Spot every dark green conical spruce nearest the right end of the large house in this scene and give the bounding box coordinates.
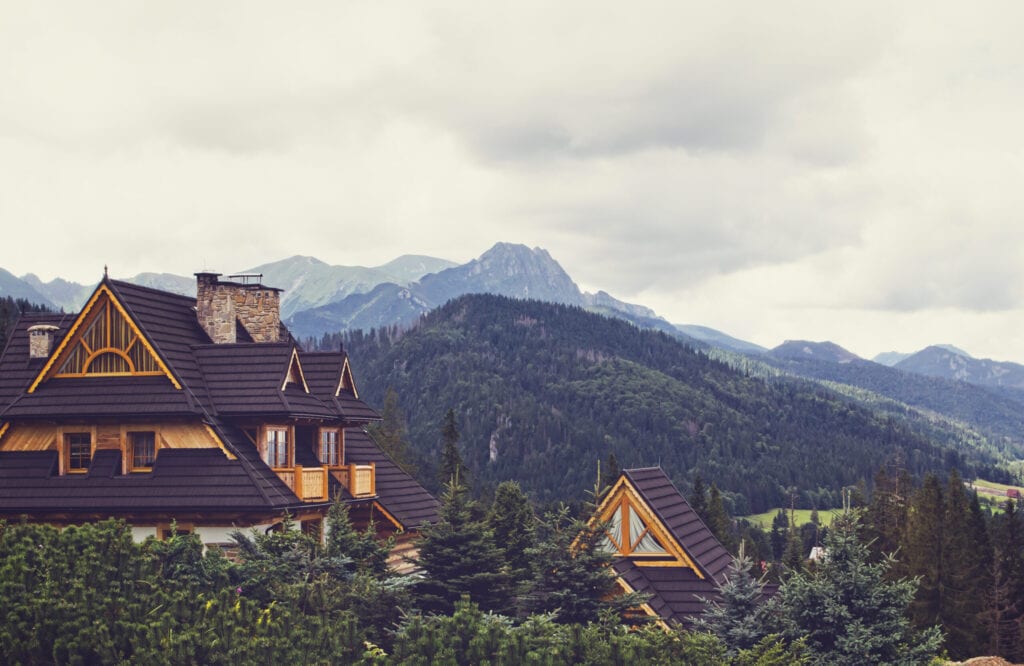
[413,477,512,613]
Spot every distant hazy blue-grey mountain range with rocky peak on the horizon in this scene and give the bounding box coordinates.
[6,243,1024,409]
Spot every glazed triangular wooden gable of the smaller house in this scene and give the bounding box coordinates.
[597,474,705,578]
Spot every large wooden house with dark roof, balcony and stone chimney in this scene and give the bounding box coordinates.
[0,273,438,545]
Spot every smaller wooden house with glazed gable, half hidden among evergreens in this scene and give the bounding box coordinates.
[597,467,732,625]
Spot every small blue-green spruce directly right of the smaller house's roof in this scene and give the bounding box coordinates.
[696,544,768,657]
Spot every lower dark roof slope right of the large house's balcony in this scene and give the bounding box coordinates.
[345,428,440,530]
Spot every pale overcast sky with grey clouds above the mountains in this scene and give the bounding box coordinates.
[0,0,1024,362]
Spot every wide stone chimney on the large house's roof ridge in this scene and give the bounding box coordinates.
[196,273,281,344]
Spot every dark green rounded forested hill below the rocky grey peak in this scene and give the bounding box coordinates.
[319,295,1000,512]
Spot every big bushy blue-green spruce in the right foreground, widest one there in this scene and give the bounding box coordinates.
[776,512,942,665]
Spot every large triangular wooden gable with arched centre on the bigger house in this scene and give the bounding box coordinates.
[28,282,181,393]
